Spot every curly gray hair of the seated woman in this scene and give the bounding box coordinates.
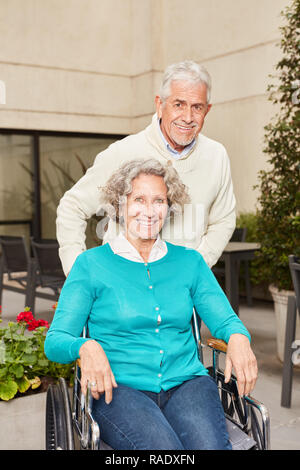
[100,158,190,221]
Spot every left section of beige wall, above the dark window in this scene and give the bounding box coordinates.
[0,0,133,133]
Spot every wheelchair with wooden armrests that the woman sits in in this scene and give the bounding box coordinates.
[46,311,270,450]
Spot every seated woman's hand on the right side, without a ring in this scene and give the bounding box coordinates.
[225,333,257,396]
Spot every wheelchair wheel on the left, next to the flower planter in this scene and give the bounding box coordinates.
[46,378,74,450]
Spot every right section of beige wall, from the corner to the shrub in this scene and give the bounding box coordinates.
[144,0,290,212]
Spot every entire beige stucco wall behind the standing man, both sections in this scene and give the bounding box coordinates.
[0,0,289,211]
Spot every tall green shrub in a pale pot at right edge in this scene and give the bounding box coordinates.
[257,0,300,360]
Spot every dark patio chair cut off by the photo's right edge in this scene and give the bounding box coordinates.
[281,255,300,408]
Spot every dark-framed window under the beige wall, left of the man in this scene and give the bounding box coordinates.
[0,126,123,248]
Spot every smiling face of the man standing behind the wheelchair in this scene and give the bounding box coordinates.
[155,80,211,152]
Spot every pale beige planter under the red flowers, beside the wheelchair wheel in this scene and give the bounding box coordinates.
[0,392,46,450]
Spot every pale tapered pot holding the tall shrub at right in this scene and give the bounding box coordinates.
[269,286,300,362]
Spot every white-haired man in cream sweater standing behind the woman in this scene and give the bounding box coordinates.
[57,61,235,274]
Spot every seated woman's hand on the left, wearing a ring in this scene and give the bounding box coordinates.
[79,340,118,404]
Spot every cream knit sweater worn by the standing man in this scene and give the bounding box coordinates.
[56,114,235,274]
